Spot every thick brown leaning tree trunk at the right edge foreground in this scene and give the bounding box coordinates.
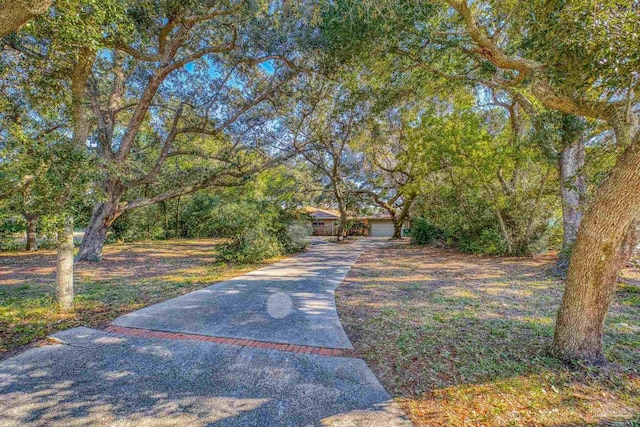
[554,132,640,363]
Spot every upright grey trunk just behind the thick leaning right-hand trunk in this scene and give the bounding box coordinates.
[556,137,587,271]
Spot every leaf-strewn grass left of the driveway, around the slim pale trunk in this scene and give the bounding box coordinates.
[0,240,280,358]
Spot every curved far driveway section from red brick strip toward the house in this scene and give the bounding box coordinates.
[113,239,370,349]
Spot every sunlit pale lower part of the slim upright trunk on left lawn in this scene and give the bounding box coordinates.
[56,215,73,310]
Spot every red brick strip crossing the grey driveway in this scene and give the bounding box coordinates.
[104,325,344,356]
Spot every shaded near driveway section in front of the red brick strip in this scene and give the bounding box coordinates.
[0,329,408,426]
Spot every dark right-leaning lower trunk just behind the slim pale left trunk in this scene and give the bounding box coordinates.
[77,201,122,262]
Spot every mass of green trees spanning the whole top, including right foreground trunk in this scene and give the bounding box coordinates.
[0,0,640,362]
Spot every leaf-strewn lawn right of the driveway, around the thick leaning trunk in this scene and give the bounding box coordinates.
[337,245,640,426]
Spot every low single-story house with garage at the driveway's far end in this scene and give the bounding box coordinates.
[304,207,410,237]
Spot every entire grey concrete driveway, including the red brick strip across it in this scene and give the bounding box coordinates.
[0,239,410,427]
